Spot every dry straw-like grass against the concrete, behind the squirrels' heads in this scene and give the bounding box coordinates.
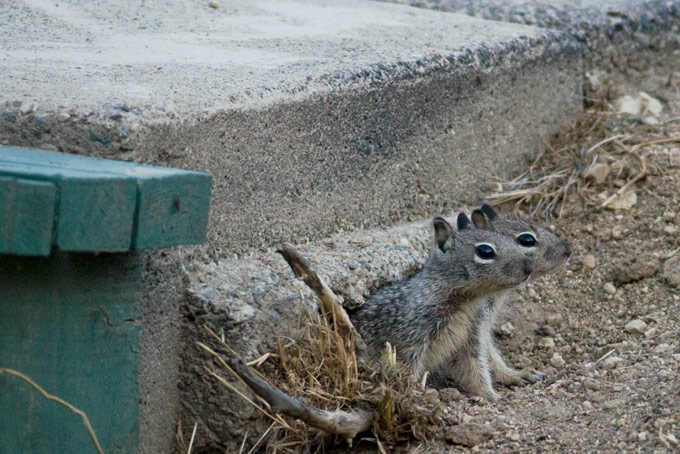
[488,101,680,219]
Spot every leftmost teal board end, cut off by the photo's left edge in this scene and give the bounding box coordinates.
[0,177,57,256]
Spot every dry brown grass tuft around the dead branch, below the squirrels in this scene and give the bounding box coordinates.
[201,296,442,453]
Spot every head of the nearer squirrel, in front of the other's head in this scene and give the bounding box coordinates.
[424,213,534,296]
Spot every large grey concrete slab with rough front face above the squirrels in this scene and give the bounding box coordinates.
[0,0,581,256]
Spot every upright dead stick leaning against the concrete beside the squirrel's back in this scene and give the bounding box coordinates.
[276,243,366,352]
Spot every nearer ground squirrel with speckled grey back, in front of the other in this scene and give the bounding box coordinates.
[350,213,534,395]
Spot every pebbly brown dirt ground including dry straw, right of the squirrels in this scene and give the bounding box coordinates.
[202,55,680,454]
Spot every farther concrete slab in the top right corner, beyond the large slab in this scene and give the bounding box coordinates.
[388,0,680,71]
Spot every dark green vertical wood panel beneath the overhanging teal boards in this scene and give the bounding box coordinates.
[0,252,143,454]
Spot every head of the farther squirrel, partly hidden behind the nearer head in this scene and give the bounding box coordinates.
[472,204,572,277]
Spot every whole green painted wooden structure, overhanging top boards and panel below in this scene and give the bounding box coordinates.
[0,146,211,454]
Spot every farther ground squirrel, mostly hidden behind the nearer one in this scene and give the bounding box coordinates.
[468,204,572,386]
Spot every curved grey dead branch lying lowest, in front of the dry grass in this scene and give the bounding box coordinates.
[224,353,373,439]
